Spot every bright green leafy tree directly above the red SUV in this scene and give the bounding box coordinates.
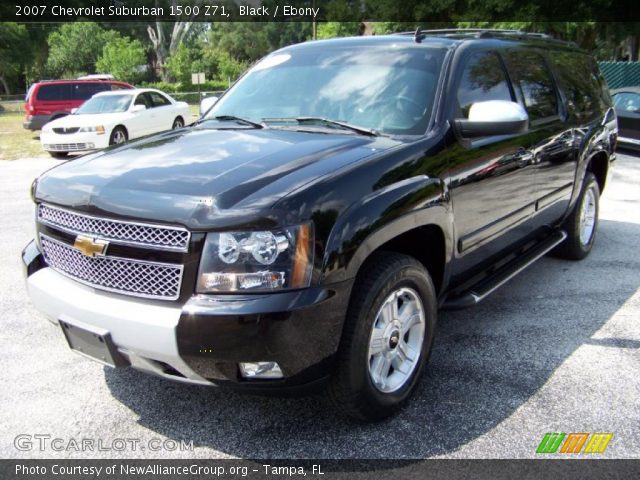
[47,22,120,76]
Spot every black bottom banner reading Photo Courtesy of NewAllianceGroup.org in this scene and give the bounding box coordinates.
[0,460,640,480]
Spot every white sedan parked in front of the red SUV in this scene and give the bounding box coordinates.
[40,88,191,157]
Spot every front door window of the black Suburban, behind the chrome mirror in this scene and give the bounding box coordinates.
[458,52,512,118]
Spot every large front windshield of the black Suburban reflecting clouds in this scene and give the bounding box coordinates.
[204,42,445,135]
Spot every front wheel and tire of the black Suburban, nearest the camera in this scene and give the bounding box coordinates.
[327,252,437,422]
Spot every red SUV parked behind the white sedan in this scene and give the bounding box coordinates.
[22,80,134,130]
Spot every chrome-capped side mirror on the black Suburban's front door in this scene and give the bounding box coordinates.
[455,100,529,137]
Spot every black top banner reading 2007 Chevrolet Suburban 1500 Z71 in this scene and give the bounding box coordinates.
[0,0,640,22]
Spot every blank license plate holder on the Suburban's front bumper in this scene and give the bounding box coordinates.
[59,319,129,367]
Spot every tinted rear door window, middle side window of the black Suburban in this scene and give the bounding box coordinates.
[507,50,558,120]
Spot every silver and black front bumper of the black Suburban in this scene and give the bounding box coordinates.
[22,242,352,391]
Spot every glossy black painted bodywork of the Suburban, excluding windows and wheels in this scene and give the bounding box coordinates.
[24,33,614,386]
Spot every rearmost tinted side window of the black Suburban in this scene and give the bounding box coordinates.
[551,52,601,114]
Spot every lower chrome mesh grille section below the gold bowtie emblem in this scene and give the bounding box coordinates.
[40,234,183,300]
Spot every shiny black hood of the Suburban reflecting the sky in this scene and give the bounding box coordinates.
[36,126,398,229]
